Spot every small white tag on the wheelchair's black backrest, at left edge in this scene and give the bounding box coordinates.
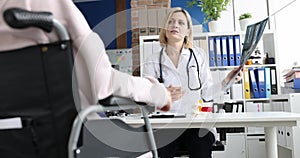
[0,117,22,130]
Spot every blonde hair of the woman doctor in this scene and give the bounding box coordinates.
[159,7,193,48]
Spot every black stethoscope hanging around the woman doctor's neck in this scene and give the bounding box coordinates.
[157,48,202,91]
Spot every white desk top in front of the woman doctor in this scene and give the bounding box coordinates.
[123,112,300,128]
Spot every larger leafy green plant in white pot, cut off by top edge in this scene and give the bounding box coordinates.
[187,0,230,32]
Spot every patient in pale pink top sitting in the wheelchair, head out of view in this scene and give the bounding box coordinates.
[0,0,171,111]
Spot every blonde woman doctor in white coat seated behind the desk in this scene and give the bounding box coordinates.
[143,8,241,158]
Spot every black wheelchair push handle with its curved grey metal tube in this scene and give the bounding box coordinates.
[3,8,70,41]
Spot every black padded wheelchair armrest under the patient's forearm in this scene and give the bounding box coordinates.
[98,95,146,107]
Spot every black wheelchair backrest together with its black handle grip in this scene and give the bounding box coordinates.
[0,8,77,158]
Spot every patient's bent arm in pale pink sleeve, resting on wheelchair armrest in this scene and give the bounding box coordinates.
[75,33,170,110]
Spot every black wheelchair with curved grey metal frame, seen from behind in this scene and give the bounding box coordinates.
[0,8,157,158]
